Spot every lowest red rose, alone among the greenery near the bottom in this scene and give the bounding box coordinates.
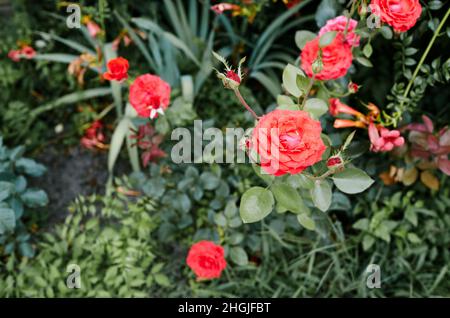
[186,241,227,279]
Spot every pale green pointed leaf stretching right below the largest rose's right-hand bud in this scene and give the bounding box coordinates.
[332,168,374,194]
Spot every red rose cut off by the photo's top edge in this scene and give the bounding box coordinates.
[370,0,422,32]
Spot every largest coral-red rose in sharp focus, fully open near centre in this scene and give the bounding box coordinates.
[252,110,326,176]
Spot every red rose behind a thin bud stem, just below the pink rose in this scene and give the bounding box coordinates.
[301,33,353,80]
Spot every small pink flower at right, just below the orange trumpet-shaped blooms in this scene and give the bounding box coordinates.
[369,123,405,152]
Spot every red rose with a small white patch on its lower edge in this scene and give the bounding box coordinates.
[130,74,171,119]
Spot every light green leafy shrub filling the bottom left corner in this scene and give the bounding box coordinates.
[0,194,172,297]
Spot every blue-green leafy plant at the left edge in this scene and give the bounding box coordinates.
[0,136,48,258]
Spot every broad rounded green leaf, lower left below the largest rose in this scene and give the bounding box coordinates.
[239,187,275,223]
